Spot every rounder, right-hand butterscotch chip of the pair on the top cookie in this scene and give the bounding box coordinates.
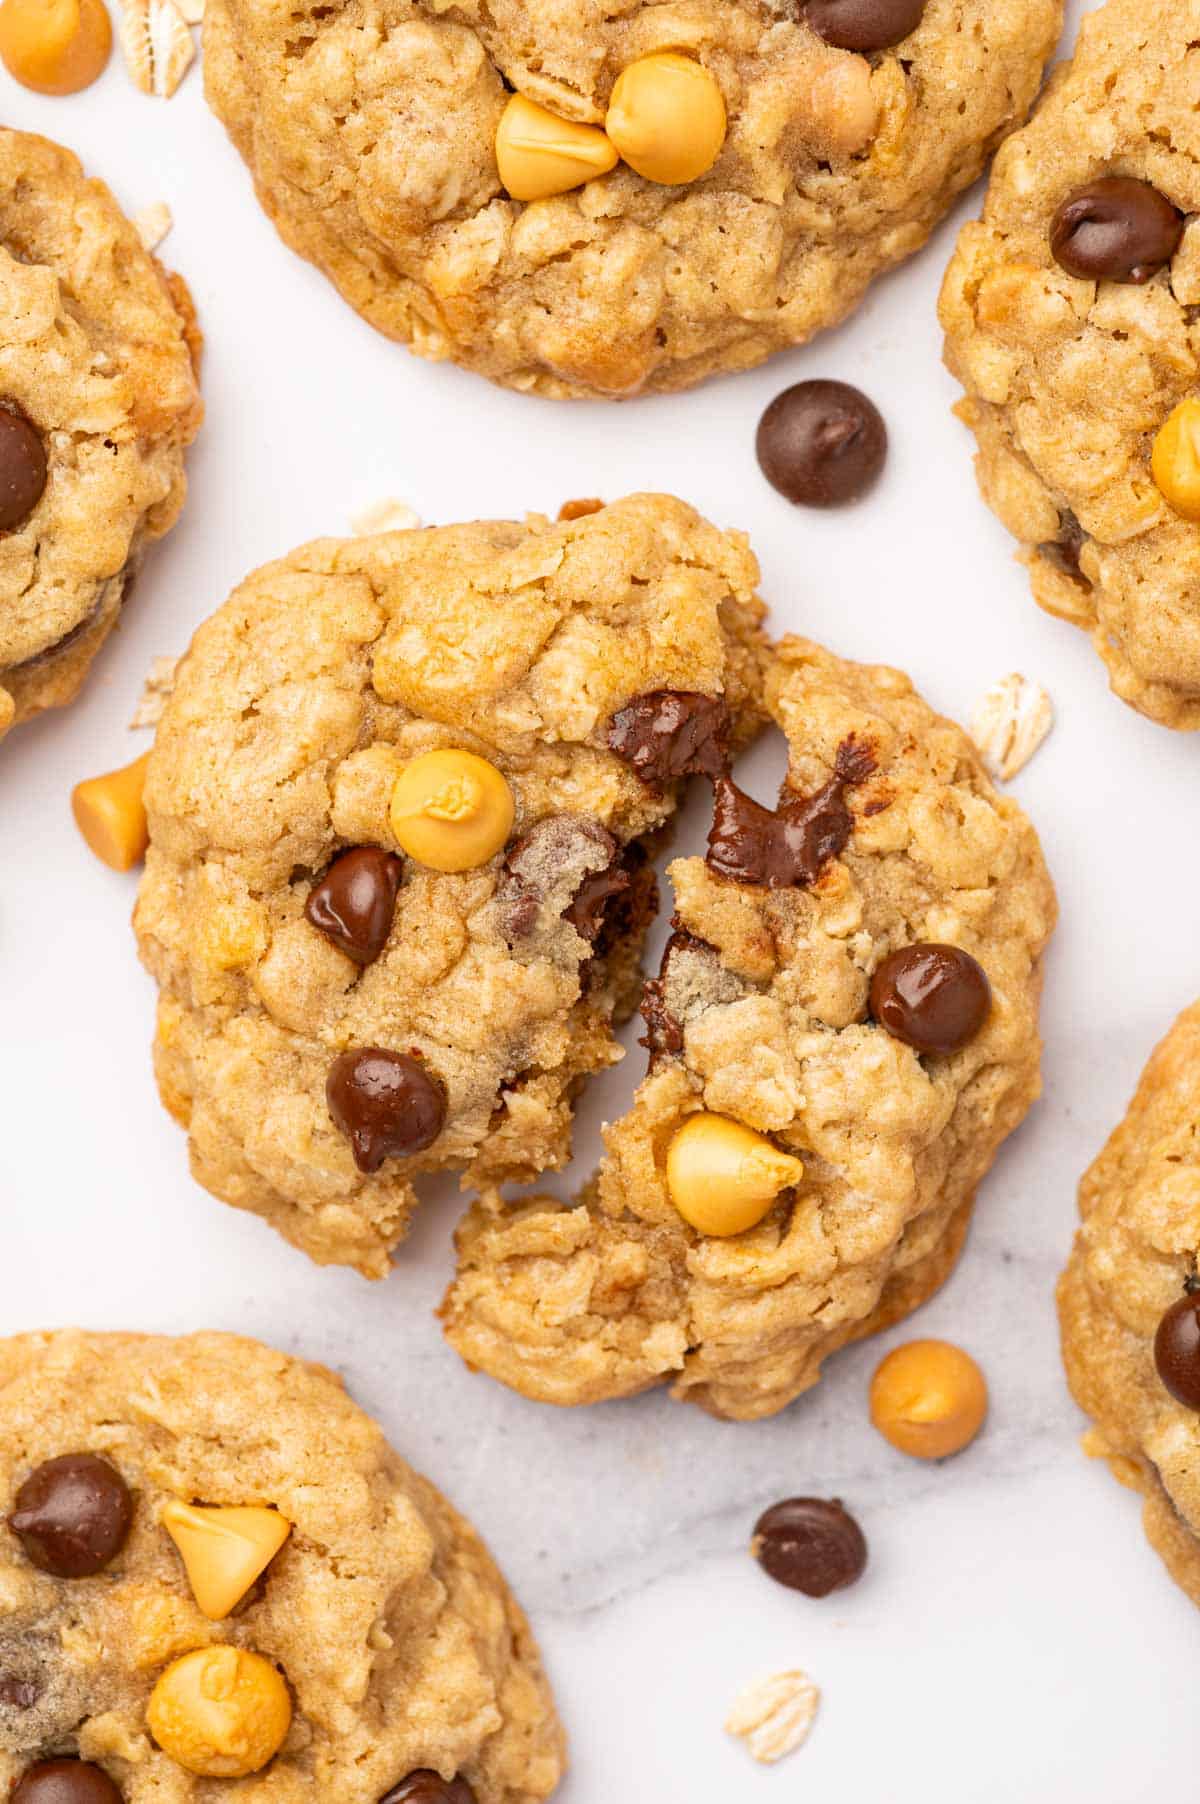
[605,51,727,186]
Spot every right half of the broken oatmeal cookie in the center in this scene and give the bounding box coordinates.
[442,639,1056,1418]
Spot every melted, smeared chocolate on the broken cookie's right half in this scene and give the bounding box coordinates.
[707,740,875,889]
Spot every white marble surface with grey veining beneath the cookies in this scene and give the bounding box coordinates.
[0,10,1200,1804]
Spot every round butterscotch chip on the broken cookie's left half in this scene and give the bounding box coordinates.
[388,749,516,871]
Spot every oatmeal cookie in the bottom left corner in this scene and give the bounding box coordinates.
[0,1331,563,1804]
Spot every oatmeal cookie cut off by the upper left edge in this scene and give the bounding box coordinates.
[0,128,200,738]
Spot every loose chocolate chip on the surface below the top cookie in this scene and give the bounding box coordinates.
[756,381,888,507]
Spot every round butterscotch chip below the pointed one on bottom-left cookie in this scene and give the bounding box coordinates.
[146,1645,292,1779]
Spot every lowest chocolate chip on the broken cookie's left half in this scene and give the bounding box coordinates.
[325,1046,446,1173]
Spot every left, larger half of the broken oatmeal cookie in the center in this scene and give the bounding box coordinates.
[135,496,762,1277]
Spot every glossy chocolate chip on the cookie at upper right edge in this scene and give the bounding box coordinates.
[1050,175,1184,283]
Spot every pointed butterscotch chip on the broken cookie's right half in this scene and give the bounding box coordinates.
[666,1111,805,1236]
